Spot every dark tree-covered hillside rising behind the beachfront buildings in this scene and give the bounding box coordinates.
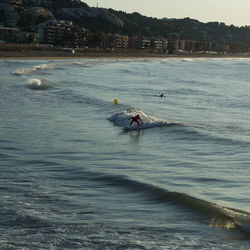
[0,0,250,48]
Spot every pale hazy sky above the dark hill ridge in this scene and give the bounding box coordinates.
[82,0,250,26]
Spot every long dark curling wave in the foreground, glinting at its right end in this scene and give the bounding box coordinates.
[95,174,250,233]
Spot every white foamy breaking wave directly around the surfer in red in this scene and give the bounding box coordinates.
[109,107,177,130]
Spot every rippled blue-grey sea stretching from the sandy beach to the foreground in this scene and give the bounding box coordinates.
[0,58,250,249]
